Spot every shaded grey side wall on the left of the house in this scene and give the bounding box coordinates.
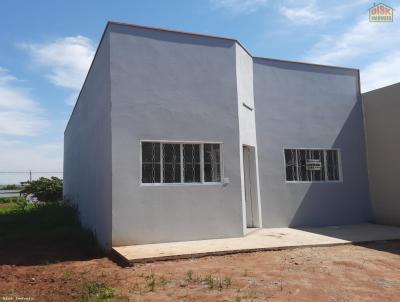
[64,33,112,248]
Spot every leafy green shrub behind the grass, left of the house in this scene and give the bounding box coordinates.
[21,176,63,202]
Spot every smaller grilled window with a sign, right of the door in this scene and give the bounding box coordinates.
[284,149,340,182]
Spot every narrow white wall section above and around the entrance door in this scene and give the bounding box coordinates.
[236,44,262,229]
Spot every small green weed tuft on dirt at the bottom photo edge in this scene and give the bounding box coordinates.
[76,281,116,302]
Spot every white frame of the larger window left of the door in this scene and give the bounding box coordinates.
[139,139,224,186]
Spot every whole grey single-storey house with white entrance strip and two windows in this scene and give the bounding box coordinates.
[64,22,371,248]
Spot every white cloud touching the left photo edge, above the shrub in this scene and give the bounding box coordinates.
[0,67,47,136]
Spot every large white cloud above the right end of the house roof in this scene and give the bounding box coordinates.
[303,6,400,92]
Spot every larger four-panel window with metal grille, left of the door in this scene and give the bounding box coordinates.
[142,142,222,184]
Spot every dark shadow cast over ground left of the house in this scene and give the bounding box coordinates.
[0,204,104,265]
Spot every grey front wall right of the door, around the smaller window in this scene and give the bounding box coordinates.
[254,58,371,227]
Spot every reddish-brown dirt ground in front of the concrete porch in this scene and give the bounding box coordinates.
[0,241,400,301]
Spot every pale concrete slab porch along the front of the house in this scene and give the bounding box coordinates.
[112,224,400,264]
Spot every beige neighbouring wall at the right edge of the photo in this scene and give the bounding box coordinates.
[363,84,400,225]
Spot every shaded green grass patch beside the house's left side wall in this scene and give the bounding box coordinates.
[0,203,101,254]
